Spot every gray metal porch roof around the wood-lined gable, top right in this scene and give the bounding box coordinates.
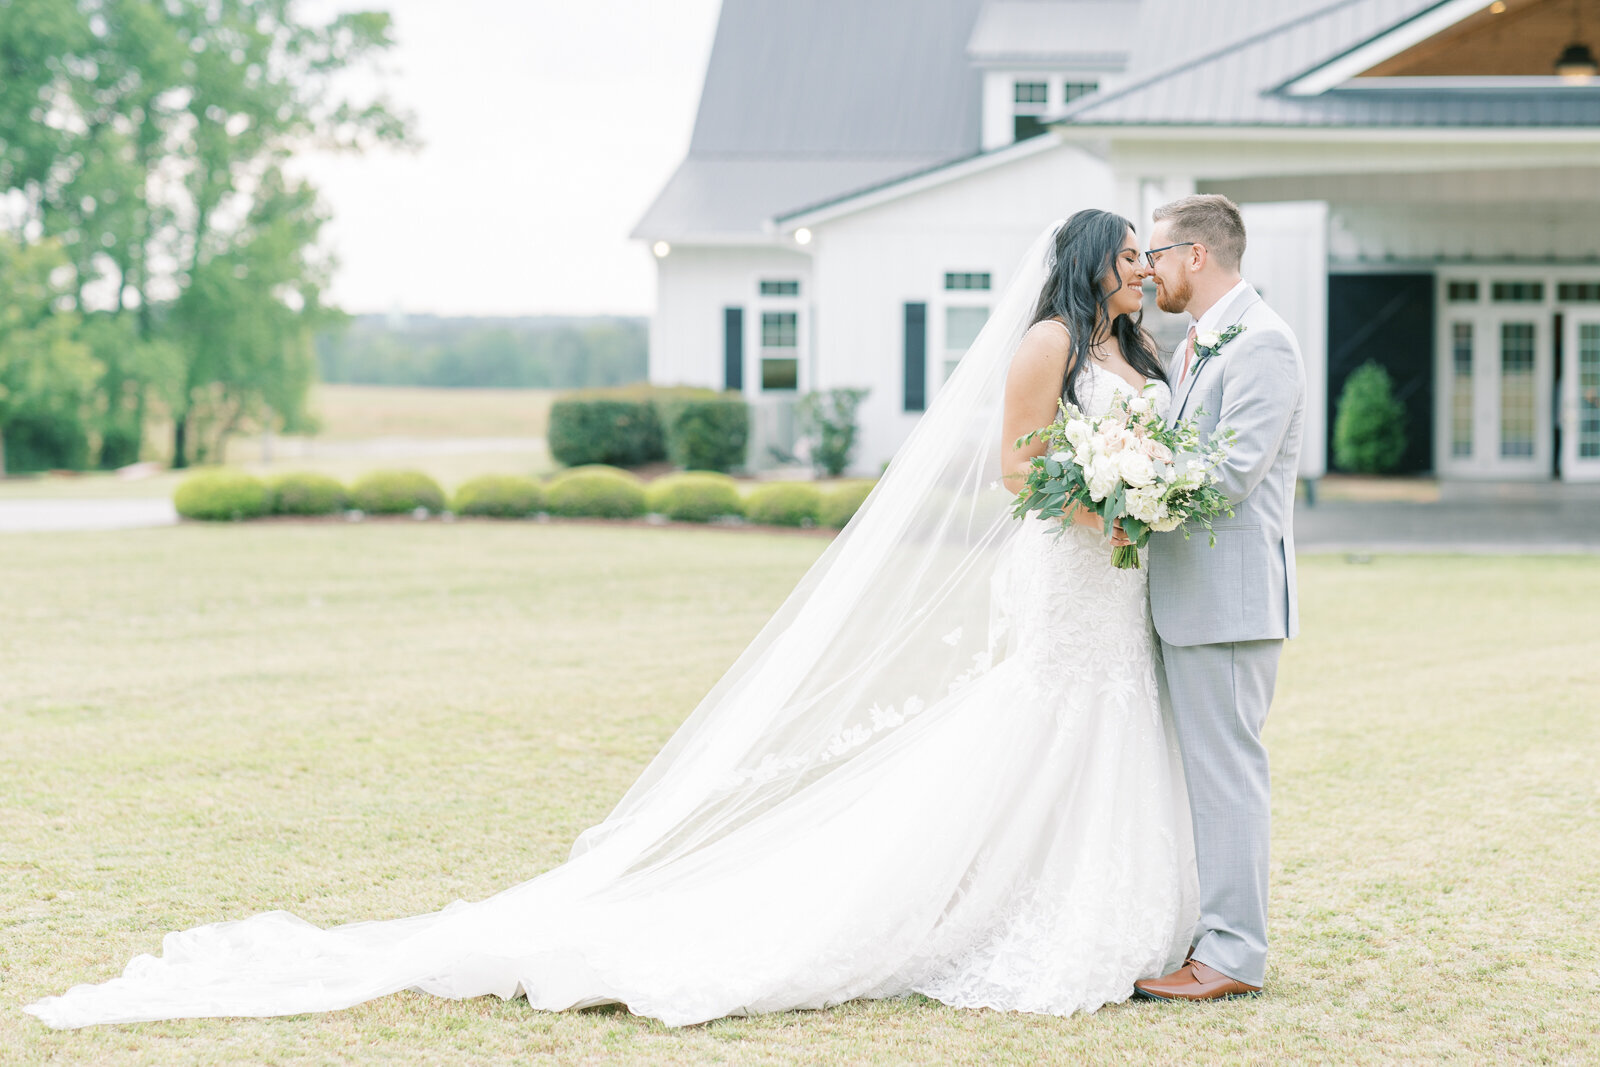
[1064,0,1600,126]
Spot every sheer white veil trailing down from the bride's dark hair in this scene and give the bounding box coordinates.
[573,221,1061,872]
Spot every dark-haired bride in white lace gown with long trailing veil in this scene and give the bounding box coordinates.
[27,211,1197,1027]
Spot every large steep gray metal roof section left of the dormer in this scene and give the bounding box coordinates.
[634,0,982,240]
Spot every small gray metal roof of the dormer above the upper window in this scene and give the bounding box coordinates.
[966,0,1142,70]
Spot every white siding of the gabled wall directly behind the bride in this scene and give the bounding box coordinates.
[813,140,1112,474]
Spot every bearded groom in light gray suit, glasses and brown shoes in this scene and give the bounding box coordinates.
[1134,195,1306,1000]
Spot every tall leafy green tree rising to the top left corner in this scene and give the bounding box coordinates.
[0,0,406,466]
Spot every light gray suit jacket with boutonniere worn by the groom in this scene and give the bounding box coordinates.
[1149,286,1306,645]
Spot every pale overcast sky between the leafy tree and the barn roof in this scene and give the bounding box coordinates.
[299,0,720,315]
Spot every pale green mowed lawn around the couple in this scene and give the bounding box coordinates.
[0,523,1600,1064]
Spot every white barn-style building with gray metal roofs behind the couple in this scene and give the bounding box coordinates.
[635,0,1600,482]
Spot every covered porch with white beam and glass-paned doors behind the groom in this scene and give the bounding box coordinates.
[1112,130,1600,483]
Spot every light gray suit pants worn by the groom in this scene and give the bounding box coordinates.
[1162,640,1283,985]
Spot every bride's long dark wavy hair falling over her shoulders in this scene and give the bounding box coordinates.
[1029,208,1166,408]
